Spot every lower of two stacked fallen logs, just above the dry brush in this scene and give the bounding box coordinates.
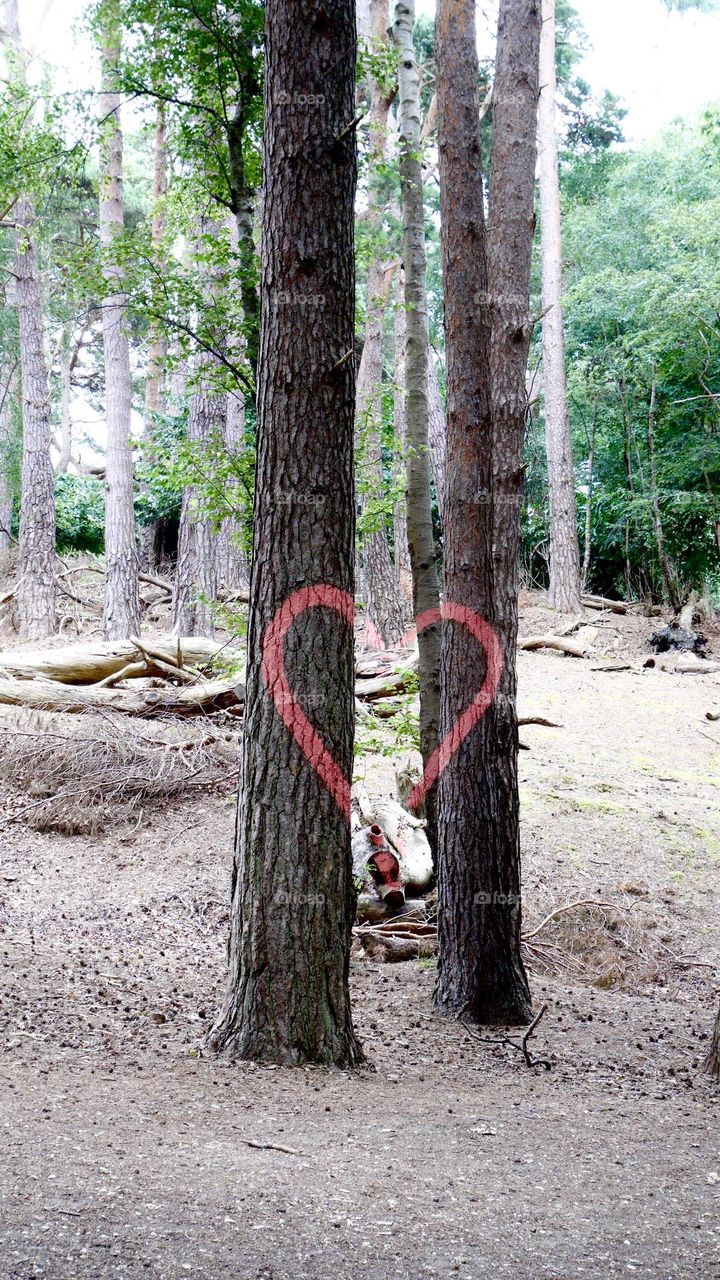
[0,673,245,717]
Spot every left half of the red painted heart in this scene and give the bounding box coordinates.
[263,584,355,822]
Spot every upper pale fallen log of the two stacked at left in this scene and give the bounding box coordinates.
[0,636,220,685]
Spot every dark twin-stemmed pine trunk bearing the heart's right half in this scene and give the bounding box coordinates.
[427,0,541,1024]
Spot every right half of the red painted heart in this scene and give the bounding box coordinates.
[407,602,502,809]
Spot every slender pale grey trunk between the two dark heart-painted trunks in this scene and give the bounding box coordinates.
[392,0,441,854]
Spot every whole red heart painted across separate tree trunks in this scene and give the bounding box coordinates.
[263,584,502,818]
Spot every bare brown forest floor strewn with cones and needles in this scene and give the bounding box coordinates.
[0,586,720,1280]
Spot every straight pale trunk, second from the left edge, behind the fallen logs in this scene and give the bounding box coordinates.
[100,0,140,640]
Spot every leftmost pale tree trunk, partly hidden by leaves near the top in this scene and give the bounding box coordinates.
[4,0,56,640]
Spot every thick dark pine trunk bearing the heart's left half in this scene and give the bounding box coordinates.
[210,0,363,1066]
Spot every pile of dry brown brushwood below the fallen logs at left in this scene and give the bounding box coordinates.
[0,710,240,836]
